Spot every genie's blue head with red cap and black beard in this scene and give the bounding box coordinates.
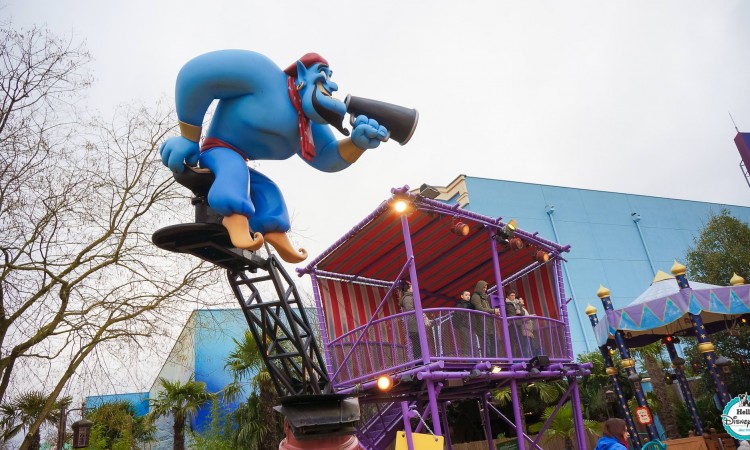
[284,53,349,136]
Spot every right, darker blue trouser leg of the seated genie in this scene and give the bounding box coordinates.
[250,169,290,234]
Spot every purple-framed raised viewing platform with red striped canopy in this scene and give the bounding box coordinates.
[297,186,591,450]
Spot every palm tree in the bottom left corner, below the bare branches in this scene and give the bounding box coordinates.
[0,391,72,450]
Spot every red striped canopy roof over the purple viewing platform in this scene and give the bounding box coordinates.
[301,189,568,299]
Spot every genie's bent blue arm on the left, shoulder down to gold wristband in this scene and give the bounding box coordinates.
[175,50,284,127]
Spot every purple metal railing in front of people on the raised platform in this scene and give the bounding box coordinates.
[328,308,569,388]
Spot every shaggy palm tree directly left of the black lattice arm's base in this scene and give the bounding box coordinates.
[224,331,280,450]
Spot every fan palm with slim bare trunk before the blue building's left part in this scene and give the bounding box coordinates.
[151,376,214,450]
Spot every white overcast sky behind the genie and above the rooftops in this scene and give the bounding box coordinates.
[5,0,750,392]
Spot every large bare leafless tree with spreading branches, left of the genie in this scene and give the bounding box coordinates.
[0,26,219,448]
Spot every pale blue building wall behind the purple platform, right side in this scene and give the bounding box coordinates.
[465,176,750,353]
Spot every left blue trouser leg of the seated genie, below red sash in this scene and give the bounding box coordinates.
[199,147,257,217]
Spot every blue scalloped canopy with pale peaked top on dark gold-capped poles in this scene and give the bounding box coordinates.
[599,271,750,347]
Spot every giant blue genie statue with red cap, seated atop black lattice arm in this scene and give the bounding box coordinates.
[161,50,394,263]
